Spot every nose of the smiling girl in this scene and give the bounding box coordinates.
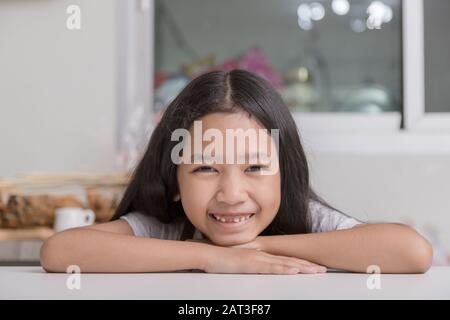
[216,172,248,205]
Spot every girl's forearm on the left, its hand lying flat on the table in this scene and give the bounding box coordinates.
[41,229,209,273]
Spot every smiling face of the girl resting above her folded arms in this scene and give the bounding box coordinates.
[177,112,281,246]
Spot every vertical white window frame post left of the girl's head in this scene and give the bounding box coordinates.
[116,0,154,171]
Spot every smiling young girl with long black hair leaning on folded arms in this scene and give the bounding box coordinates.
[41,70,433,274]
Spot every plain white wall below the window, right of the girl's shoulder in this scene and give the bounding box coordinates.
[308,152,450,252]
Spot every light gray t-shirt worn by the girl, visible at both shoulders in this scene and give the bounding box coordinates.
[120,201,362,240]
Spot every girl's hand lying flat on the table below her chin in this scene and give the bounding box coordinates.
[203,246,327,274]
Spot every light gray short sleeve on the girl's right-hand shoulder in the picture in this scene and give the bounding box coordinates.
[309,201,363,232]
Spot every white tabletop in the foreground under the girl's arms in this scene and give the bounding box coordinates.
[0,267,450,300]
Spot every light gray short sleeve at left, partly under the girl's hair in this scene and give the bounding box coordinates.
[120,212,183,240]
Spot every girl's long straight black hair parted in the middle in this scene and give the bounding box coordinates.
[112,70,338,235]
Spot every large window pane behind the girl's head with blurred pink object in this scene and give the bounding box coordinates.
[154,0,403,114]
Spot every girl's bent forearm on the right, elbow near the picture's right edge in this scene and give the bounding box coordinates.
[260,224,433,273]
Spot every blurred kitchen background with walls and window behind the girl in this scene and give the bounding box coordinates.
[0,0,450,265]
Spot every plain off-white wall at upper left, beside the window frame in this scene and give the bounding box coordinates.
[0,0,117,177]
